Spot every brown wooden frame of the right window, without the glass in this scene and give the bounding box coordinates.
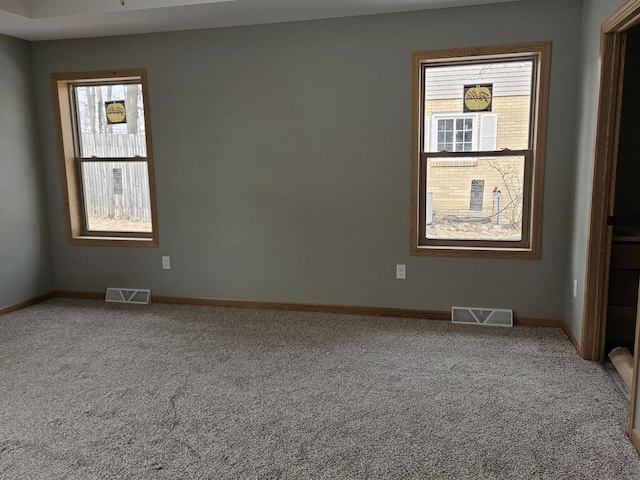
[410,42,551,259]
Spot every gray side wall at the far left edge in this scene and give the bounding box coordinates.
[0,35,53,308]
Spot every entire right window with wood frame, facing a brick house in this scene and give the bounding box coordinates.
[411,43,551,258]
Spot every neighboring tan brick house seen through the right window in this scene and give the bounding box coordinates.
[424,62,533,231]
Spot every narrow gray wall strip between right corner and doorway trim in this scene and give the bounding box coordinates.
[564,0,626,340]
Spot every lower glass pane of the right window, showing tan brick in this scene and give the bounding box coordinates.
[425,156,524,241]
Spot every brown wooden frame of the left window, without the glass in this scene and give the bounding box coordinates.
[51,68,159,247]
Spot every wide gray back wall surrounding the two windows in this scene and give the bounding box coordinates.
[33,0,581,318]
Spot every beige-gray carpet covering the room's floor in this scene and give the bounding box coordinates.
[0,299,640,480]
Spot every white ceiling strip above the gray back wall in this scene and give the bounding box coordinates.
[0,0,518,40]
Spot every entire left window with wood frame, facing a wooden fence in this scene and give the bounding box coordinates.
[52,69,158,246]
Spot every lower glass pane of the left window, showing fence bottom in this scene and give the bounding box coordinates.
[82,162,151,232]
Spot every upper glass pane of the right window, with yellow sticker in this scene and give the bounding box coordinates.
[424,60,533,152]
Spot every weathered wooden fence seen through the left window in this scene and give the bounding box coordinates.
[81,133,151,222]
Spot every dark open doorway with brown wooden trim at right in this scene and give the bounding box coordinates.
[581,0,640,451]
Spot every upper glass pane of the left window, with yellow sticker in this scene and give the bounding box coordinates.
[73,83,147,158]
